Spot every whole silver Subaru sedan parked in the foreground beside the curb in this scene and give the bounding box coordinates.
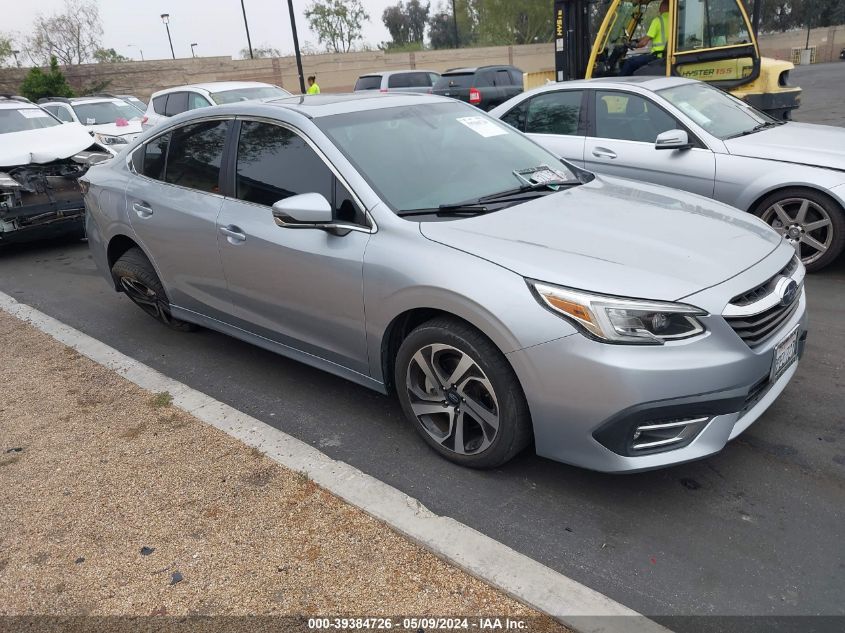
[83,94,807,472]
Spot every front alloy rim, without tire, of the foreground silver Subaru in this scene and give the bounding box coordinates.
[405,344,499,455]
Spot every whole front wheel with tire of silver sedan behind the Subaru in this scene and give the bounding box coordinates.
[751,187,845,272]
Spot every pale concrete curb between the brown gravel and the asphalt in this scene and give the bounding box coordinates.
[0,292,668,633]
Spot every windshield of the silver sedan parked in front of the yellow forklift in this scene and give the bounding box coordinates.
[657,83,777,139]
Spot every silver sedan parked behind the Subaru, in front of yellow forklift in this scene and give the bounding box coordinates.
[490,77,845,271]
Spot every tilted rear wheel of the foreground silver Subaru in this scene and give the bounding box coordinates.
[111,247,197,332]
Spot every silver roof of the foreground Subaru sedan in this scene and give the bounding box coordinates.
[258,91,460,119]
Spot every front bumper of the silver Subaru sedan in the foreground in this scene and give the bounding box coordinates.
[508,289,807,472]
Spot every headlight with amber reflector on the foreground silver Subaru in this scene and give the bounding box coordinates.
[529,281,707,345]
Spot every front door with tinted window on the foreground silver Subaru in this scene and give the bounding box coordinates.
[218,121,370,374]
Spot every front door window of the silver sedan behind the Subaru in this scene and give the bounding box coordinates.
[595,90,681,143]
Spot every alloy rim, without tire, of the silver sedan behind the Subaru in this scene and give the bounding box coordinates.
[760,198,833,265]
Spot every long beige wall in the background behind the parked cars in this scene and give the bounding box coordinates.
[0,26,845,98]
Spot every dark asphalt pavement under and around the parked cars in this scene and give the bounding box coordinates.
[0,63,845,631]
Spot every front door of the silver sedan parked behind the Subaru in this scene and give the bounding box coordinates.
[584,90,716,197]
